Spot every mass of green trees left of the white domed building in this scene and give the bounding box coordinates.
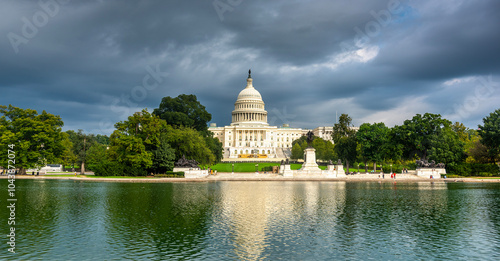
[0,94,222,176]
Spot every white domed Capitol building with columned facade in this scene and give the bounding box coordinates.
[208,71,358,161]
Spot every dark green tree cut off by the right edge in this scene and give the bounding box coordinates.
[479,109,500,163]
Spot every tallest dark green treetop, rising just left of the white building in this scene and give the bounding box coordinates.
[153,94,212,132]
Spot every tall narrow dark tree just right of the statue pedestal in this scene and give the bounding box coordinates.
[332,114,357,171]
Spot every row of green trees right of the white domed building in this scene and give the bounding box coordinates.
[292,109,500,174]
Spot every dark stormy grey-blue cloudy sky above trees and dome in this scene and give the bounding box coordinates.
[0,0,500,134]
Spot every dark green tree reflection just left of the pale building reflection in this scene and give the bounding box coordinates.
[106,183,213,259]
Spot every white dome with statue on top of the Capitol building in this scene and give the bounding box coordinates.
[231,70,269,126]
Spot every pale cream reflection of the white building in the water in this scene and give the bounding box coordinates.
[209,182,345,260]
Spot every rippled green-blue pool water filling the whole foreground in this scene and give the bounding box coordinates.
[0,180,500,260]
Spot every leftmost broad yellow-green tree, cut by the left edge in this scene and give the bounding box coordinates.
[0,105,64,174]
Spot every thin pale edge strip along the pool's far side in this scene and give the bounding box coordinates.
[0,173,500,183]
